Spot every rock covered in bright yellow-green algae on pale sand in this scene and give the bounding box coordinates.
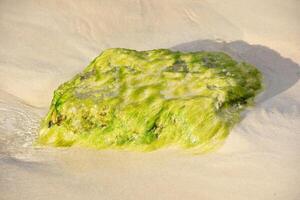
[38,48,262,152]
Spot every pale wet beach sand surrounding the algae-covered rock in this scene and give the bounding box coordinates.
[0,0,300,200]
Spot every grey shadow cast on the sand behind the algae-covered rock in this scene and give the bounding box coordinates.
[170,40,300,103]
